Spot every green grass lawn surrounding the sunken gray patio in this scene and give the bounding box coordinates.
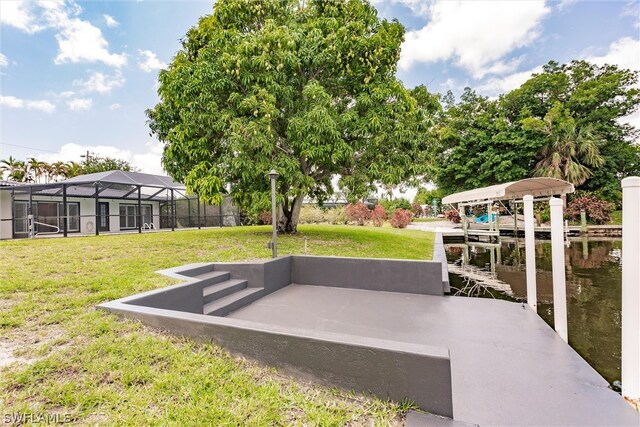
[0,225,433,426]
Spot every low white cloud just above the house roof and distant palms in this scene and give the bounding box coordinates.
[38,141,165,175]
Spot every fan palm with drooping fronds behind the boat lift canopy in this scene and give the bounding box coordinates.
[523,102,605,186]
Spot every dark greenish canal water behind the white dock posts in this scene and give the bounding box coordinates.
[445,238,622,383]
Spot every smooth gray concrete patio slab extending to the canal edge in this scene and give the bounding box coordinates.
[228,284,640,426]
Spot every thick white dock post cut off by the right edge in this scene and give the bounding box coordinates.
[622,176,640,399]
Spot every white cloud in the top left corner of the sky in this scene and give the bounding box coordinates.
[0,0,127,68]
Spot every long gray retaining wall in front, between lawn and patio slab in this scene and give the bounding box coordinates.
[99,301,453,417]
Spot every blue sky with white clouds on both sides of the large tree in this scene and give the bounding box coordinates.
[0,0,640,173]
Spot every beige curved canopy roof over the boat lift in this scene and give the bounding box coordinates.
[442,178,575,204]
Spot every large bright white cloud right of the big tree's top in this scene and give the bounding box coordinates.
[399,0,550,79]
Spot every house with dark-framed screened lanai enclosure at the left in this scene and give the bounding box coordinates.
[0,171,240,239]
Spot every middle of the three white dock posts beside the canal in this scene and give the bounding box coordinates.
[549,197,569,342]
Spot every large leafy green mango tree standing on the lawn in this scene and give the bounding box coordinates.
[147,0,439,232]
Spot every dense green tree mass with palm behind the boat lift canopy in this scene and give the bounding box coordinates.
[435,61,640,201]
